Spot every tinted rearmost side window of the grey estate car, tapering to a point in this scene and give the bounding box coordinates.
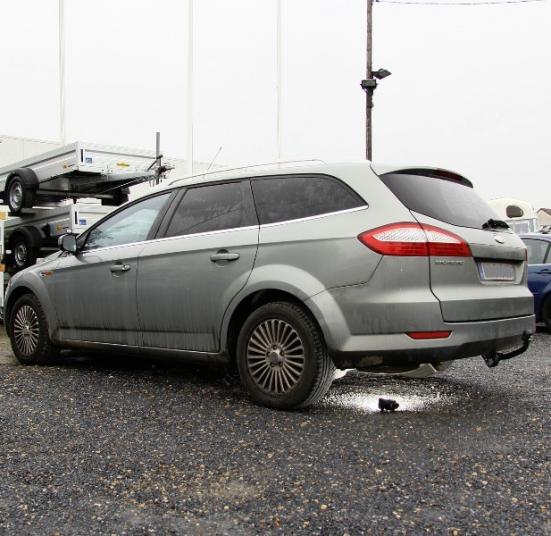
[252,175,366,224]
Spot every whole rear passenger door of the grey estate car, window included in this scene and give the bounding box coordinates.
[137,180,258,352]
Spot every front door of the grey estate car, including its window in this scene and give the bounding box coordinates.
[54,192,170,346]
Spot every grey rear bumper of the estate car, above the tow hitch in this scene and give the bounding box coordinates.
[308,292,535,368]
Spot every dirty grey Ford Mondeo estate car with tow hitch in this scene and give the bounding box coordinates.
[5,162,535,408]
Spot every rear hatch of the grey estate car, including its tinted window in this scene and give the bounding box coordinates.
[379,165,533,322]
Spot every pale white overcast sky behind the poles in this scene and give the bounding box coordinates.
[0,0,551,208]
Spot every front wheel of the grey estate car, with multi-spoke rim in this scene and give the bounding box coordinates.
[6,294,59,365]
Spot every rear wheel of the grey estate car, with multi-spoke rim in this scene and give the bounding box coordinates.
[236,302,335,409]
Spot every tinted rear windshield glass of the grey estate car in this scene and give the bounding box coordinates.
[380,172,498,229]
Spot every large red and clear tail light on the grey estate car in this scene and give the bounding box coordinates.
[358,222,471,257]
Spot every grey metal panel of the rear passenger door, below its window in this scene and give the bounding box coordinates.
[137,226,258,352]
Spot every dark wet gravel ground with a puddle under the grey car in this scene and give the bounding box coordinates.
[0,326,551,535]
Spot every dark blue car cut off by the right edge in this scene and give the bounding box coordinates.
[521,233,551,331]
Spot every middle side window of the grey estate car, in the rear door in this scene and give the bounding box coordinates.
[165,181,258,236]
